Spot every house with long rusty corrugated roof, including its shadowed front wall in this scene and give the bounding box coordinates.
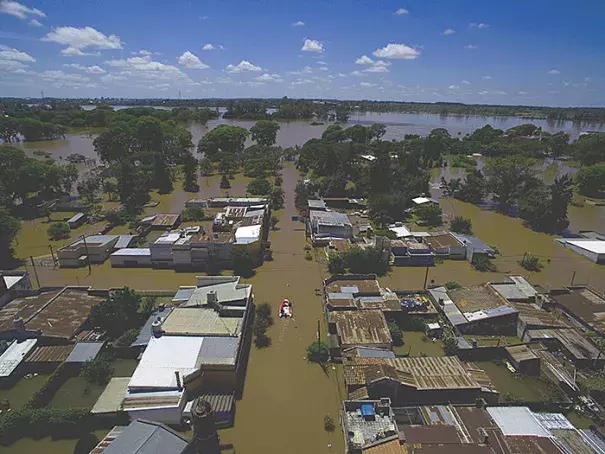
[343,356,499,406]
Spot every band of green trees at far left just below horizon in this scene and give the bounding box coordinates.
[0,100,218,142]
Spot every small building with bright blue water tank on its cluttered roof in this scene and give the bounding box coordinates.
[342,398,407,454]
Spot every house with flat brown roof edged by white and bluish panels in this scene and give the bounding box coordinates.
[429,284,519,335]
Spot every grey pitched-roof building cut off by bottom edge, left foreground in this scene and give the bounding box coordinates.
[90,419,189,454]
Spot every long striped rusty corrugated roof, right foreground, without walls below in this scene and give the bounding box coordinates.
[344,356,481,390]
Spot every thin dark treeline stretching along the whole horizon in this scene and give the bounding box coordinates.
[0,97,605,124]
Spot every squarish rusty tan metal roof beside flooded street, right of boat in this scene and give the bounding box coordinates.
[330,310,393,345]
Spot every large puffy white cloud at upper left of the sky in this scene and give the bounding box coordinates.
[42,27,122,56]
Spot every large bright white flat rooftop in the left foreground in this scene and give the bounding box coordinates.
[128,336,204,391]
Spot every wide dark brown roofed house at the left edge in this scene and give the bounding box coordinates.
[0,287,104,344]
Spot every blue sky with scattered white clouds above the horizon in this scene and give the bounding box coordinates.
[0,0,605,106]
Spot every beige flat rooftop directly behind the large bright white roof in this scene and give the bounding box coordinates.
[162,307,243,340]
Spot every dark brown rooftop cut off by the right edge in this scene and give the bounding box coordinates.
[550,287,605,331]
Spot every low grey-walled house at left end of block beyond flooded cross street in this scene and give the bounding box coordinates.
[57,235,135,268]
